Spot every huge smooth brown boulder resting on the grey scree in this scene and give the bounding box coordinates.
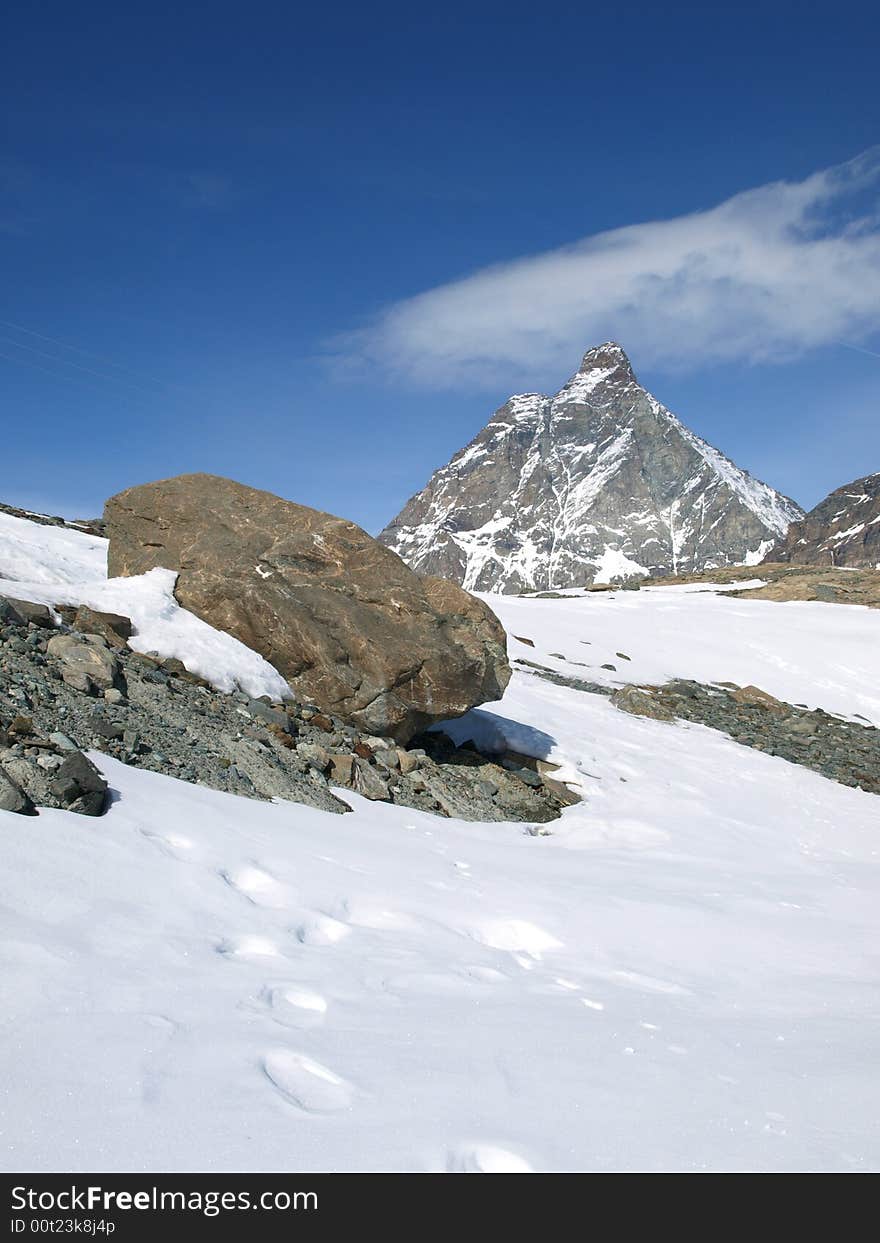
[104,475,510,741]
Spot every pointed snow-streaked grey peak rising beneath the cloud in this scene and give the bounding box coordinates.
[379,342,803,593]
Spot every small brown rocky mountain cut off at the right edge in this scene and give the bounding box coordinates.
[767,471,880,569]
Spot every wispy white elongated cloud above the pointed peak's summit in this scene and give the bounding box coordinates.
[341,148,880,385]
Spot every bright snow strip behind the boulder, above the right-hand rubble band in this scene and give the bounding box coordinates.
[481,573,880,726]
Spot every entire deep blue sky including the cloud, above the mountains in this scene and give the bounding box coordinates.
[0,0,880,531]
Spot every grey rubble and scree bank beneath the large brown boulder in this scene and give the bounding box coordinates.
[0,597,577,824]
